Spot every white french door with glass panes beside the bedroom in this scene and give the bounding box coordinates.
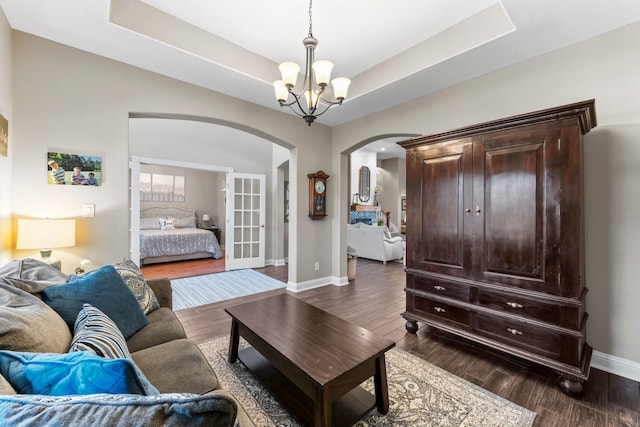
[225,172,266,270]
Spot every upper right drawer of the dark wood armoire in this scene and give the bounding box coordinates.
[478,289,561,325]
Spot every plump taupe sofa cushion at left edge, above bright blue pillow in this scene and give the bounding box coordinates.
[0,284,71,353]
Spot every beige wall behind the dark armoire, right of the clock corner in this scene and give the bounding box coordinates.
[332,24,640,363]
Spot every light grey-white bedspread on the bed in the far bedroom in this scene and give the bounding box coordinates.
[140,228,222,259]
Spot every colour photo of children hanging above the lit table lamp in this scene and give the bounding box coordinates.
[47,151,102,186]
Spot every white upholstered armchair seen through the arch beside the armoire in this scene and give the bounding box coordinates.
[347,223,403,264]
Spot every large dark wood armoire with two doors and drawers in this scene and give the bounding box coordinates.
[400,100,596,394]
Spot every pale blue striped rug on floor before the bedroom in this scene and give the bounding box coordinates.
[171,269,287,311]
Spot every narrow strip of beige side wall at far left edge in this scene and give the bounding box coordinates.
[0,9,13,265]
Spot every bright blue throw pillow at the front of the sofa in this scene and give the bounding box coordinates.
[0,351,158,396]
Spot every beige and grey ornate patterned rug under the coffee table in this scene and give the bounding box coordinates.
[199,337,536,427]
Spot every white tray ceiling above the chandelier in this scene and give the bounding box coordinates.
[0,0,640,157]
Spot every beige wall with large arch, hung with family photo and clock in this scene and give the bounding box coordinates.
[12,32,331,283]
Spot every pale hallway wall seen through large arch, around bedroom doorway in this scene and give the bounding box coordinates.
[129,113,295,284]
